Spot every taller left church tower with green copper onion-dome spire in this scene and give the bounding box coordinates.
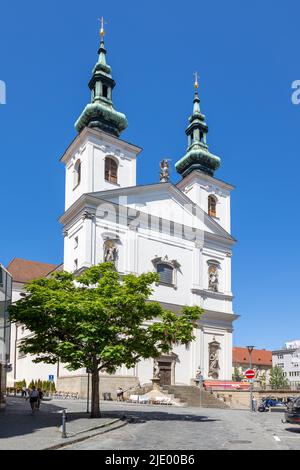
[61,18,141,210]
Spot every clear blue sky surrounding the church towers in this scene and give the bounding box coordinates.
[0,0,300,348]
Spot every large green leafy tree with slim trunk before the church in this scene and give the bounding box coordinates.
[9,263,203,417]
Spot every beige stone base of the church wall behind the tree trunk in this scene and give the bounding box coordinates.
[56,374,139,400]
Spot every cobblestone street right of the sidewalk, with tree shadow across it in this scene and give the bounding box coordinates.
[64,404,300,450]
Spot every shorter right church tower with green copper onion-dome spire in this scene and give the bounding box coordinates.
[175,73,234,233]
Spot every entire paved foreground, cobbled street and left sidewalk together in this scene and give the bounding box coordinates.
[0,398,300,450]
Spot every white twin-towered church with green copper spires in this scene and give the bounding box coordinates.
[7,25,237,396]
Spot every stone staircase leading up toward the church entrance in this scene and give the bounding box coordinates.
[161,385,228,409]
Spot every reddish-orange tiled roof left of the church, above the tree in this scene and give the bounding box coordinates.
[7,258,57,282]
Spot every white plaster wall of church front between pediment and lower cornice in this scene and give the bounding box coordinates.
[64,219,232,313]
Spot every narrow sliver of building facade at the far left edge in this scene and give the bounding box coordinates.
[0,264,12,409]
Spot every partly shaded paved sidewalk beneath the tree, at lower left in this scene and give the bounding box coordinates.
[0,397,126,450]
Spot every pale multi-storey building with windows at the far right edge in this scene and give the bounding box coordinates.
[272,339,300,389]
